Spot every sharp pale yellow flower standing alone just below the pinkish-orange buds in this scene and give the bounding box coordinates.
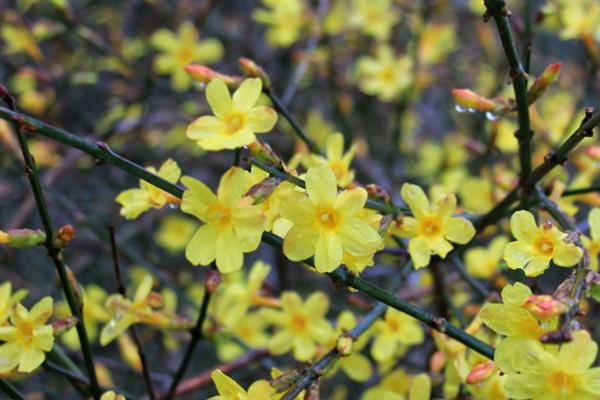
[187,78,277,150]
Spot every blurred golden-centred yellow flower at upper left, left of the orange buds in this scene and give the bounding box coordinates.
[150,21,224,92]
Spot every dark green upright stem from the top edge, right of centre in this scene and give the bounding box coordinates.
[484,0,533,181]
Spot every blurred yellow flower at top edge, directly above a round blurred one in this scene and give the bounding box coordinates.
[348,0,400,40]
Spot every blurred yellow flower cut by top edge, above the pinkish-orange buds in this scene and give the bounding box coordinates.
[252,0,306,47]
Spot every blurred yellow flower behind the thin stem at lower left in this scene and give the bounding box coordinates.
[55,283,110,350]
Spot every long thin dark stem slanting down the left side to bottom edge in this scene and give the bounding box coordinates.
[2,96,100,398]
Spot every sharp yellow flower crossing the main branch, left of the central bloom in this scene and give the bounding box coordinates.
[181,167,266,273]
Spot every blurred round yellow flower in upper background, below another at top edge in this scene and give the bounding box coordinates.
[356,45,413,102]
